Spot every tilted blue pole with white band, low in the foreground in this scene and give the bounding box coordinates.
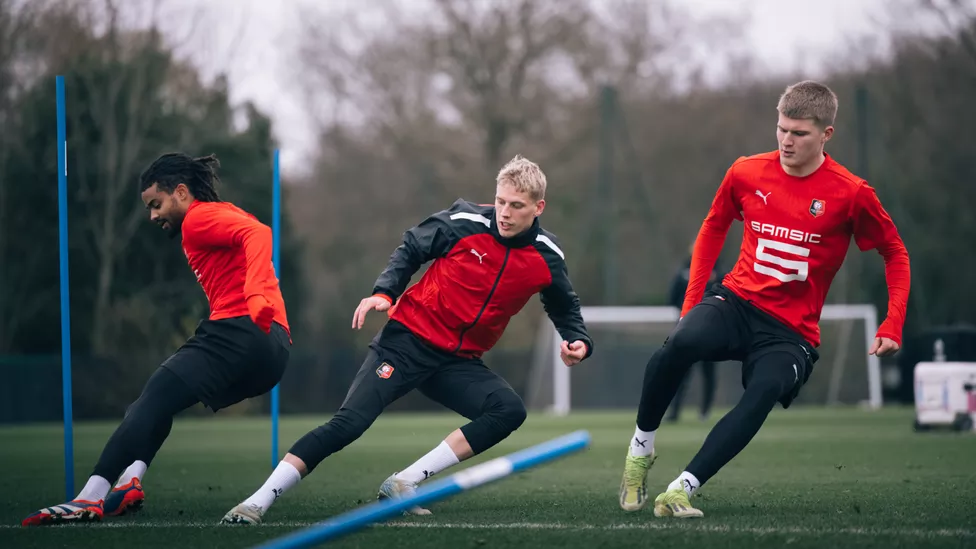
[248,431,590,549]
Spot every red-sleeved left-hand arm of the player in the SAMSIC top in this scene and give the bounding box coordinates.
[681,165,742,317]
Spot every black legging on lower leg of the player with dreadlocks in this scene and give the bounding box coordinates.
[92,367,200,483]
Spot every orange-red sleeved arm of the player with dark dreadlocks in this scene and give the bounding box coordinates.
[183,208,275,332]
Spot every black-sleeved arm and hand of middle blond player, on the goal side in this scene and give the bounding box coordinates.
[539,239,593,365]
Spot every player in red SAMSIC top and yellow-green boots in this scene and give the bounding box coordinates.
[620,81,911,518]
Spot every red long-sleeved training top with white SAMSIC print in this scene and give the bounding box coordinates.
[681,151,911,346]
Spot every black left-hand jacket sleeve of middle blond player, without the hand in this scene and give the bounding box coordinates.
[373,200,464,303]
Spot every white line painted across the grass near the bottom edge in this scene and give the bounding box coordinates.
[0,520,976,538]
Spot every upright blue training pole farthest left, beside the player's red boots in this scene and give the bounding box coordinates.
[55,76,75,501]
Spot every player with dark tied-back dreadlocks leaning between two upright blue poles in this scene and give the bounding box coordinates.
[23,153,291,526]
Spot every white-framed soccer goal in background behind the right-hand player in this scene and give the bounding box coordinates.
[527,305,882,415]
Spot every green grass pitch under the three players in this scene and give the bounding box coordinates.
[0,408,976,549]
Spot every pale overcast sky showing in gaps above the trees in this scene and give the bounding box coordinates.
[141,0,948,171]
